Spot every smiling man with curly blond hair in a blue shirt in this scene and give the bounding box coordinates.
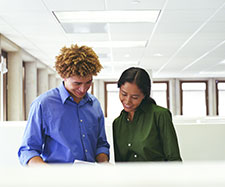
[18,45,109,165]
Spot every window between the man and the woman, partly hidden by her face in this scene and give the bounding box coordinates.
[104,82,123,119]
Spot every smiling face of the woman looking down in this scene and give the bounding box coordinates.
[119,82,145,113]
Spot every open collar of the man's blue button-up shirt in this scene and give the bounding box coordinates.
[58,81,93,104]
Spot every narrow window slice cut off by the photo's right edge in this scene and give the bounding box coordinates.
[216,80,225,116]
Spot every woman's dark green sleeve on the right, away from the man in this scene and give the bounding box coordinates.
[158,110,182,161]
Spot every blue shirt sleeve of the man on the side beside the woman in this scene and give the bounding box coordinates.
[96,110,110,157]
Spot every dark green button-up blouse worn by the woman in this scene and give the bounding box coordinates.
[113,98,181,162]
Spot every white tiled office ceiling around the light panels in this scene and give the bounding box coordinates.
[0,0,225,78]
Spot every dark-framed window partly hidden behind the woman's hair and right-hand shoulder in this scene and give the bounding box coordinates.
[151,81,169,109]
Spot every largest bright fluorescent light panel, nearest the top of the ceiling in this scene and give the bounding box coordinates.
[54,10,160,23]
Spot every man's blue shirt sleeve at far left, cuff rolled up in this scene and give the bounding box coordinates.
[18,102,43,165]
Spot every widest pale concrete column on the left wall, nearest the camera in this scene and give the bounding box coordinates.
[7,50,25,121]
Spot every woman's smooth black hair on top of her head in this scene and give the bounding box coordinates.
[117,67,151,98]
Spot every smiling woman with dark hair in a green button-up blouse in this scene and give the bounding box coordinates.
[113,67,182,162]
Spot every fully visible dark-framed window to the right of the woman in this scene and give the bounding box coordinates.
[180,81,208,116]
